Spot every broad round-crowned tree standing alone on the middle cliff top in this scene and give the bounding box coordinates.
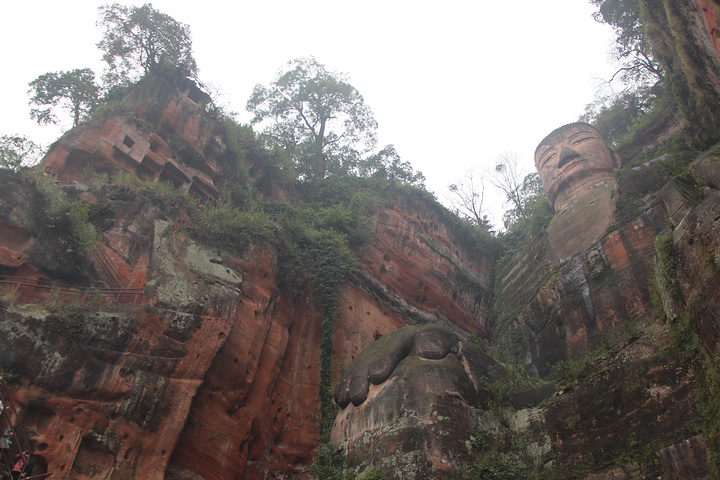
[247,57,377,180]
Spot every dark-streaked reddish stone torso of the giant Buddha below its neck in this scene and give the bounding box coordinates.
[495,158,668,376]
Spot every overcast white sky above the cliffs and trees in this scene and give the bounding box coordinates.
[0,0,612,228]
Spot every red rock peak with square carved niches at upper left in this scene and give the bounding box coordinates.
[43,77,225,202]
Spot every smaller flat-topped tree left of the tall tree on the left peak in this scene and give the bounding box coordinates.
[28,68,99,126]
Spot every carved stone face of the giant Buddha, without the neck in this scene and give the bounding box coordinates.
[535,123,620,211]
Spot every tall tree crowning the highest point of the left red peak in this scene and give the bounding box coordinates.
[97,3,197,85]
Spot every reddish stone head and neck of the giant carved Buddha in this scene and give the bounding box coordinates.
[535,123,620,260]
